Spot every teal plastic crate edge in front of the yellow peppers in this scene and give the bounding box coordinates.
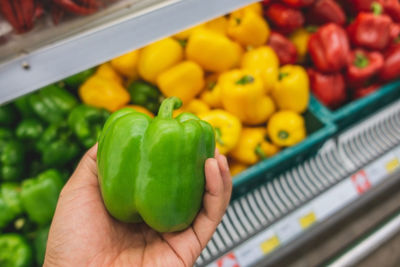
[232,98,337,199]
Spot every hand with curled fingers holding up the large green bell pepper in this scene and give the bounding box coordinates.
[44,145,232,267]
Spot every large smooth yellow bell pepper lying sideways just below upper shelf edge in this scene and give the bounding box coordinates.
[186,28,243,72]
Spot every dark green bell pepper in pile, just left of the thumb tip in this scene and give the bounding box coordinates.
[36,121,81,167]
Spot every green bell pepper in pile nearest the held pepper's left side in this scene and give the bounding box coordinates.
[68,104,110,148]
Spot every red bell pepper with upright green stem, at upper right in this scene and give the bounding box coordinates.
[347,3,392,50]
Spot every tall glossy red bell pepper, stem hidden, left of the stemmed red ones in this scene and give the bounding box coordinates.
[308,23,350,73]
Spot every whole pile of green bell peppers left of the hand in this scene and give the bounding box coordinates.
[0,80,110,267]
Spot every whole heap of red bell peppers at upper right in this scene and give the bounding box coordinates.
[263,0,400,108]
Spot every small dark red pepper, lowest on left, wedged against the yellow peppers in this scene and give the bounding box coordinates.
[268,32,297,65]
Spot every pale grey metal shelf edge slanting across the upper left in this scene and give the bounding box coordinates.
[0,0,256,104]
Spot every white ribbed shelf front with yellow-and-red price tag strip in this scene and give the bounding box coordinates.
[196,100,400,266]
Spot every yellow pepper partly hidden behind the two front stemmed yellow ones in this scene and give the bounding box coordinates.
[241,46,279,93]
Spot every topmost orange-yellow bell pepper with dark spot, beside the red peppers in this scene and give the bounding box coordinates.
[228,10,270,46]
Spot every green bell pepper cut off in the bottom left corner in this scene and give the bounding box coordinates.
[0,233,33,267]
